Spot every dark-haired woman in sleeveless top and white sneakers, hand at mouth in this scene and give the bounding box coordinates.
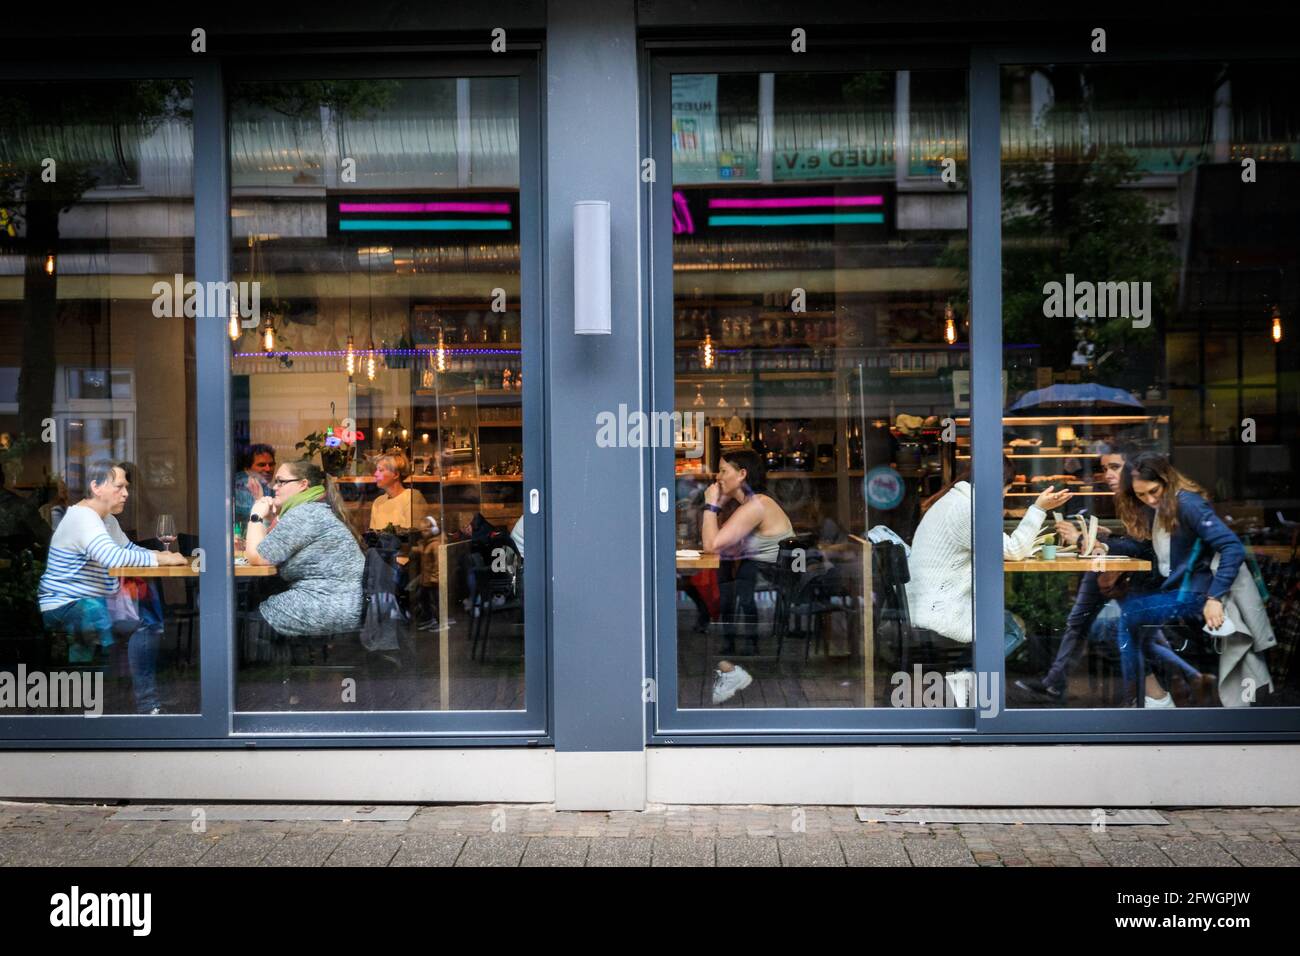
[699,449,794,704]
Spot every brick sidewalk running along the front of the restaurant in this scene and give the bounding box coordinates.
[0,803,1300,866]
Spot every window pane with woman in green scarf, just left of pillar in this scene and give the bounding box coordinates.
[230,77,532,711]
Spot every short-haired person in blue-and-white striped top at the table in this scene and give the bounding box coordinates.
[36,460,187,714]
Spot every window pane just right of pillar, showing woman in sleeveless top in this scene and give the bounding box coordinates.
[672,70,974,709]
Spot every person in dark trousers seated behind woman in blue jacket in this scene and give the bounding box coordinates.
[1015,444,1165,704]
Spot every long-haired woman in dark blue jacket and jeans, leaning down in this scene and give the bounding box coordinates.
[1112,451,1245,706]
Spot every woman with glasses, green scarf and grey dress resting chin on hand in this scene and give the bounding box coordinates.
[246,460,365,640]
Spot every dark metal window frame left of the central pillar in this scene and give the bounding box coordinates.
[0,52,553,749]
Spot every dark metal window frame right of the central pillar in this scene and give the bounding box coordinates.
[641,40,1300,745]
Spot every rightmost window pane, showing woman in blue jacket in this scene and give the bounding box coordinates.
[1002,62,1300,710]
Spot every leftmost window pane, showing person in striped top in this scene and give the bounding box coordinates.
[0,79,202,715]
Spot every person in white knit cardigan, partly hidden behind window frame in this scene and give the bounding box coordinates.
[907,457,1073,644]
